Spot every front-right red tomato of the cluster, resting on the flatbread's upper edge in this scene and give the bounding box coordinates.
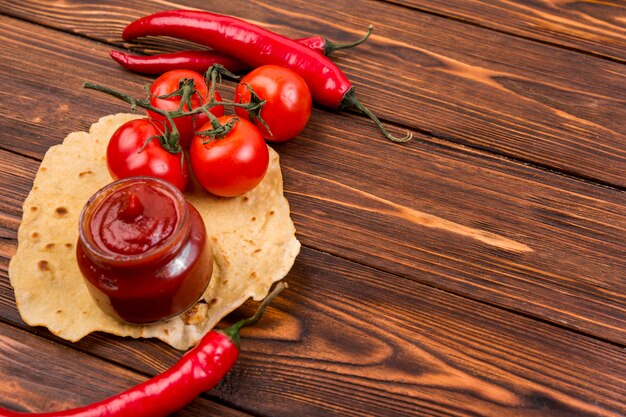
[189,116,269,197]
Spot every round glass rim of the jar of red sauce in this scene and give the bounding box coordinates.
[78,176,189,267]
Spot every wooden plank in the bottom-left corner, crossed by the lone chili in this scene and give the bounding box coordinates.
[0,322,254,417]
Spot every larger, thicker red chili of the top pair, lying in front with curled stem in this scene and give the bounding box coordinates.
[122,10,412,142]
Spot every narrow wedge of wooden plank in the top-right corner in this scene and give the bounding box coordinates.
[389,0,626,62]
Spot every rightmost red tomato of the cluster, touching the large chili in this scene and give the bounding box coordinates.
[235,65,311,142]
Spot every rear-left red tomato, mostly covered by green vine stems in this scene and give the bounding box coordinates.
[148,70,224,149]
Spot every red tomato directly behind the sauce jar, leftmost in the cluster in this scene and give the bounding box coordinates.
[106,119,189,191]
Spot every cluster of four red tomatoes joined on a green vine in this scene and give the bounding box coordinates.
[106,65,312,197]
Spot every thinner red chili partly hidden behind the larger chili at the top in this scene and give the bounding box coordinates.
[109,25,374,74]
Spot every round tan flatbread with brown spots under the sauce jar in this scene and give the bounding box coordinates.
[9,114,300,349]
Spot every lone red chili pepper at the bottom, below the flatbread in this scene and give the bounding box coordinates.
[0,283,286,417]
